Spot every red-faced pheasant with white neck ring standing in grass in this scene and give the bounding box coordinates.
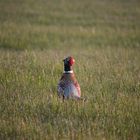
[57,56,81,99]
